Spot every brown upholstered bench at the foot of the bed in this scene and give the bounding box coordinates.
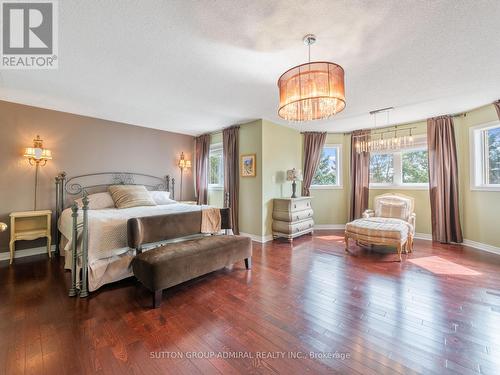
[127,209,252,308]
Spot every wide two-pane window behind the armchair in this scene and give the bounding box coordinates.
[370,136,429,189]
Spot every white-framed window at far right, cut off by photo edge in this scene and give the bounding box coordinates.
[470,122,500,190]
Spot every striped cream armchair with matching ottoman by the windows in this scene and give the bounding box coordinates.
[345,193,416,260]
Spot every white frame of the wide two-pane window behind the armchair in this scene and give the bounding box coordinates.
[369,135,429,190]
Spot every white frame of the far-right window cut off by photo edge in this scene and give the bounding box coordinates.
[469,120,500,191]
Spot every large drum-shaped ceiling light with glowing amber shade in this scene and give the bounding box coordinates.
[278,34,345,121]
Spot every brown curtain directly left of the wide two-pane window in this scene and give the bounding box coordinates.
[349,130,370,220]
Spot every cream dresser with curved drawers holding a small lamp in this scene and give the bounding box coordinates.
[273,197,314,242]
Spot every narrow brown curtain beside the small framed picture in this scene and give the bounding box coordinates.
[222,126,240,234]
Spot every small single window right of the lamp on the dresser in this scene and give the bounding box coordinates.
[311,145,342,189]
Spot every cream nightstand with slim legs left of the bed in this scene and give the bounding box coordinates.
[10,210,52,264]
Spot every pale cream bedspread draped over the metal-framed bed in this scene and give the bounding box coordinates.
[58,202,201,268]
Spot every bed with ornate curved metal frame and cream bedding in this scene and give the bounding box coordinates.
[55,172,215,297]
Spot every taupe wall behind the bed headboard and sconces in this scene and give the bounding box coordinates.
[0,101,194,251]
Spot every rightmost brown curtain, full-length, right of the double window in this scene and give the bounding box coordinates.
[427,116,463,243]
